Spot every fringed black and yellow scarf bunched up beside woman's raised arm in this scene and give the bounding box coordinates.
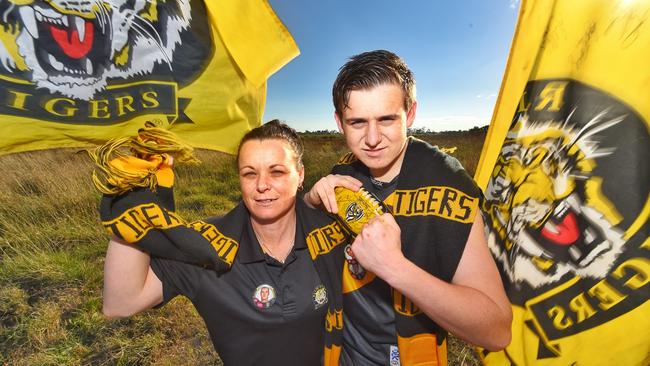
[89,126,237,272]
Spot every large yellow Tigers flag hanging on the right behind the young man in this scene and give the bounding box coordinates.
[476,0,650,365]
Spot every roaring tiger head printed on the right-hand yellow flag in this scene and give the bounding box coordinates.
[483,111,625,287]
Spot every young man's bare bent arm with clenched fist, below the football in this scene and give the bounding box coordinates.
[352,215,512,351]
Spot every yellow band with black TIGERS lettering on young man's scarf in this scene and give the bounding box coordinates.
[384,186,479,223]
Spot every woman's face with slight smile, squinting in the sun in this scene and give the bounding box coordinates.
[238,139,304,223]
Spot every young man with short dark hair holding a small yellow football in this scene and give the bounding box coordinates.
[305,51,512,366]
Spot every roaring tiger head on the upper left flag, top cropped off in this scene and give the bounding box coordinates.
[0,0,191,100]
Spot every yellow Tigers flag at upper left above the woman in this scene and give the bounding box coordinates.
[0,0,299,154]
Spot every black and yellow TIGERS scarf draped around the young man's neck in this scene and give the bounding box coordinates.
[326,138,481,366]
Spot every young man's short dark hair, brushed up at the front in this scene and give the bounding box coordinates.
[332,50,415,117]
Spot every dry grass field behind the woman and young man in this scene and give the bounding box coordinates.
[0,129,485,365]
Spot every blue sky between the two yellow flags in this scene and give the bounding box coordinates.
[264,0,519,131]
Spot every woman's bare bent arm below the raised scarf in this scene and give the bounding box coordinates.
[102,237,163,318]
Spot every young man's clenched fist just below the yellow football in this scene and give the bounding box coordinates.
[351,214,404,278]
